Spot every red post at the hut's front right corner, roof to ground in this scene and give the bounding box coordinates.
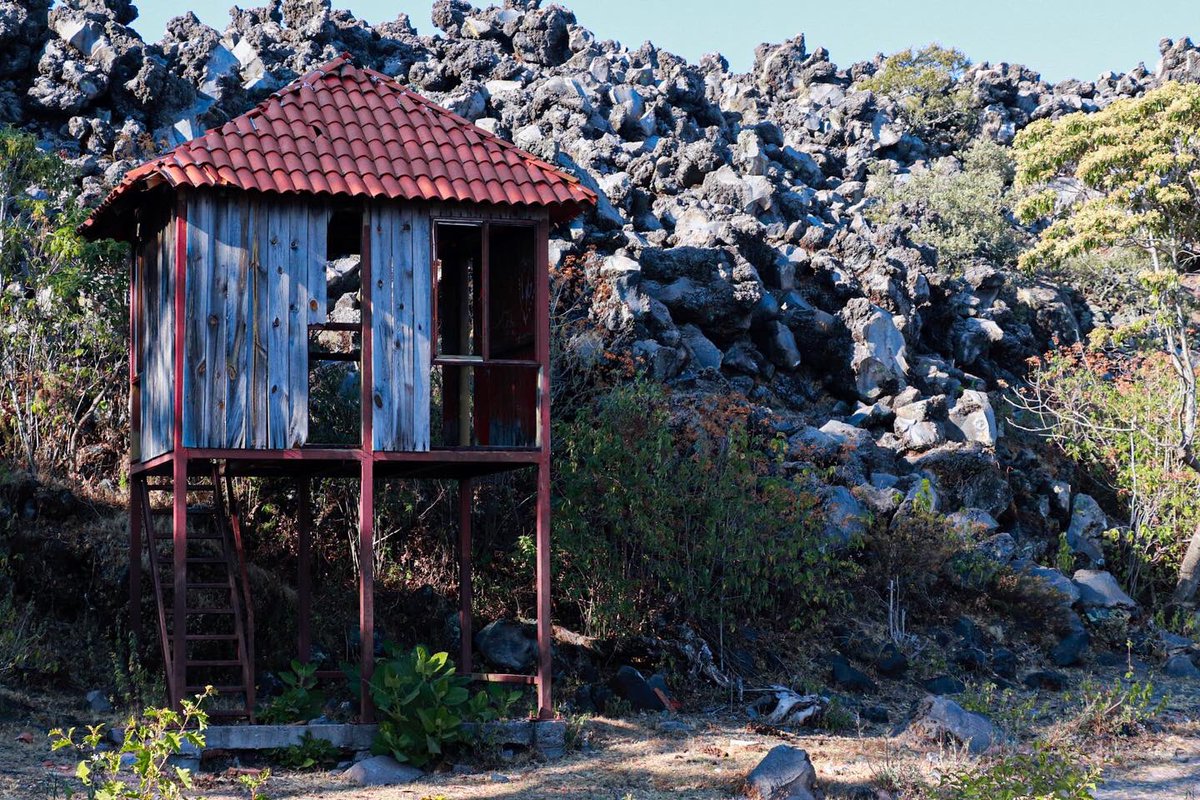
[535,222,554,720]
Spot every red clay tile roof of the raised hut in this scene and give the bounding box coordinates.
[82,55,595,236]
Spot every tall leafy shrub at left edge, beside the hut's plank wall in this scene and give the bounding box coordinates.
[0,128,128,475]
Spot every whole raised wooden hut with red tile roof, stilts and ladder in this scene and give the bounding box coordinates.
[83,55,595,721]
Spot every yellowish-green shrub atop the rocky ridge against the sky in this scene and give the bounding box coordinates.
[859,44,978,140]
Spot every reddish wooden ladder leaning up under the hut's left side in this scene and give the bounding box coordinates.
[140,463,254,722]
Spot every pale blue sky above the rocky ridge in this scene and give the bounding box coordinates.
[126,0,1200,80]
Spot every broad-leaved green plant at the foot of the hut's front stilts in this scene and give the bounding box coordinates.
[371,645,520,766]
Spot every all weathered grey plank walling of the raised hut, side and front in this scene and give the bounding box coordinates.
[140,192,496,458]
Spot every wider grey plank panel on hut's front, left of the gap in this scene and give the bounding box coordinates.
[177,192,329,450]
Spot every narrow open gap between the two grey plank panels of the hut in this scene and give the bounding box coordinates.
[308,206,362,447]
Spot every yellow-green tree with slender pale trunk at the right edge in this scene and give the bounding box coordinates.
[1014,83,1200,603]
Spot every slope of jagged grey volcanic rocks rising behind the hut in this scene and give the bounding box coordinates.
[0,0,1200,663]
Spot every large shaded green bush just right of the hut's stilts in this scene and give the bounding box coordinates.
[554,381,853,636]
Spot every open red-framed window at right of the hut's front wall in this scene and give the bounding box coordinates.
[430,222,540,447]
